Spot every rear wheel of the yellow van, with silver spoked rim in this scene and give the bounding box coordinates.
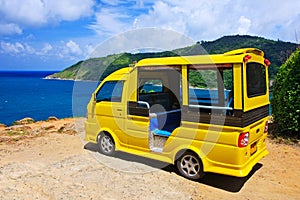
[176,151,203,180]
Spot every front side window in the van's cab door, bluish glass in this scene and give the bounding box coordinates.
[96,81,124,102]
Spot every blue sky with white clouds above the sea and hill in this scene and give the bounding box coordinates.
[0,0,300,70]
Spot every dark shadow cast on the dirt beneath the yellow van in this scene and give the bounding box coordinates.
[84,143,263,193]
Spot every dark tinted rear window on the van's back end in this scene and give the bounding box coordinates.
[246,63,267,98]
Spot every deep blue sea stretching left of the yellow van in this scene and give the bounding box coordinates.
[0,71,98,125]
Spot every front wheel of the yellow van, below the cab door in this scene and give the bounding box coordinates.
[98,133,115,156]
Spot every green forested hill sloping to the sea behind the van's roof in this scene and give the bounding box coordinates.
[49,35,297,81]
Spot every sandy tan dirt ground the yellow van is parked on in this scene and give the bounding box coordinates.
[0,119,300,200]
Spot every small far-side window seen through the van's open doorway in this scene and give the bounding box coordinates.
[139,79,163,94]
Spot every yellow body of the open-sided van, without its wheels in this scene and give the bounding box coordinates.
[85,48,269,179]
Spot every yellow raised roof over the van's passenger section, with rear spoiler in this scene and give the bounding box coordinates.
[135,48,264,67]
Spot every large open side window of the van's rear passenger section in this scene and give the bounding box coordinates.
[188,64,234,110]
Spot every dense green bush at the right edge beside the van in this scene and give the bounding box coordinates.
[271,49,300,138]
